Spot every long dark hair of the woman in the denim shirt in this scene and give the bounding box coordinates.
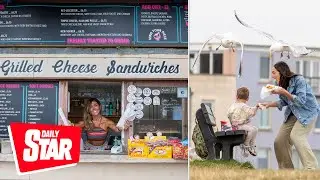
[274,61,297,89]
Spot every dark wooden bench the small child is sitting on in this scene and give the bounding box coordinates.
[196,103,246,160]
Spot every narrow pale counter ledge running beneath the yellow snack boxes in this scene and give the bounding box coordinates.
[0,153,188,164]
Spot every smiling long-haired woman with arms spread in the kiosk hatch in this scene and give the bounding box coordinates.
[73,98,129,150]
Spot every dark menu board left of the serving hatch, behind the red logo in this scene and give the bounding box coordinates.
[0,82,59,138]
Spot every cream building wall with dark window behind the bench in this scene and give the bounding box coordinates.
[189,43,237,148]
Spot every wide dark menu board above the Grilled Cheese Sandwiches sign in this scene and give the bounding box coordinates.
[0,4,188,46]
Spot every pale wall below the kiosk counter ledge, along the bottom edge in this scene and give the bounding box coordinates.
[0,162,188,180]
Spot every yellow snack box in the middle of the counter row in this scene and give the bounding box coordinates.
[145,136,172,159]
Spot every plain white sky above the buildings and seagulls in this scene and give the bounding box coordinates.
[189,0,320,48]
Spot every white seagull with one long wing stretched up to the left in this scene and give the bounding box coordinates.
[234,11,314,59]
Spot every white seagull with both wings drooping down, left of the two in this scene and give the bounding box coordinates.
[192,32,243,77]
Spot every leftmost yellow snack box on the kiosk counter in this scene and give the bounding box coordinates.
[128,139,149,158]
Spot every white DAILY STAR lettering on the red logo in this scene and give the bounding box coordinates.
[23,129,72,162]
